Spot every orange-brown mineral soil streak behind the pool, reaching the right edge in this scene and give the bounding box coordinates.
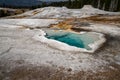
[50,15,120,32]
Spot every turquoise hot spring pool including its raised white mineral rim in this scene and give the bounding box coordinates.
[34,30,106,53]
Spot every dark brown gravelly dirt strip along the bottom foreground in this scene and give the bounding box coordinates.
[1,64,120,80]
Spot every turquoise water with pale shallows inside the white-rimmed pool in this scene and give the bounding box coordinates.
[46,30,96,50]
